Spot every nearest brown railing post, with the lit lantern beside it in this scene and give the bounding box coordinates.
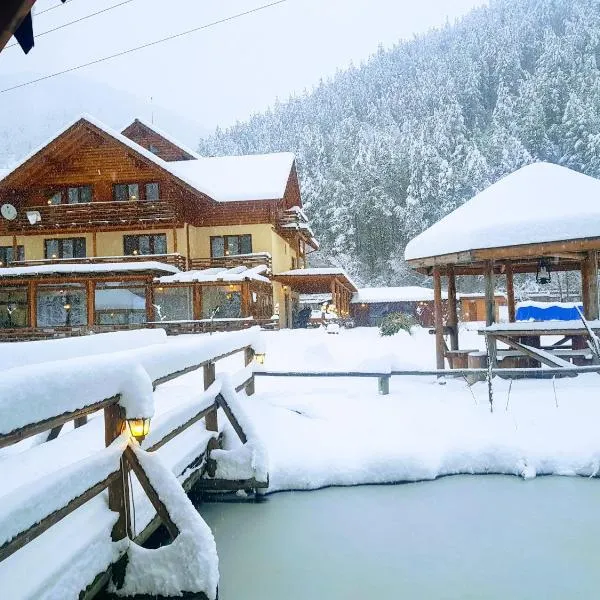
[104,402,131,542]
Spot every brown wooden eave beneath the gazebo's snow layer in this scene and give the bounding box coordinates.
[406,237,600,275]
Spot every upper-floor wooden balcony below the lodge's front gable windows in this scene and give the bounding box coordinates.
[0,200,178,235]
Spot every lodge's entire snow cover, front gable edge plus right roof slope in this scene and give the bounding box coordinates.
[1,114,294,202]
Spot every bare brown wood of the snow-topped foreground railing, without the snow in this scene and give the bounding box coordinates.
[0,336,268,595]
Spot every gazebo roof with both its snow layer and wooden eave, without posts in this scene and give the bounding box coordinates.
[405,162,600,274]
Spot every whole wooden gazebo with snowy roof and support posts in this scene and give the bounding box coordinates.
[405,163,600,369]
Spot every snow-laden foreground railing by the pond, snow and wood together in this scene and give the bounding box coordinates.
[0,328,268,599]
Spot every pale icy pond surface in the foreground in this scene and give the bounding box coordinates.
[200,475,600,600]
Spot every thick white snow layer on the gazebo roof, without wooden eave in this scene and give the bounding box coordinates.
[405,162,600,260]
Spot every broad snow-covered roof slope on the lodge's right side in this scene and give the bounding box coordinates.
[167,152,294,202]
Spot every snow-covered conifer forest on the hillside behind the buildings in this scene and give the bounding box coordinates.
[200,0,600,284]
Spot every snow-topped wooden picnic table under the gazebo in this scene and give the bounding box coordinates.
[478,320,600,369]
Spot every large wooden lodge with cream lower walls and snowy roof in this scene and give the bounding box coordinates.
[0,116,354,339]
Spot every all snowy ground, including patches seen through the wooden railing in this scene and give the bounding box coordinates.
[0,324,600,598]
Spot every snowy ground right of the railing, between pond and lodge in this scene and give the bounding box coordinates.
[238,327,600,491]
